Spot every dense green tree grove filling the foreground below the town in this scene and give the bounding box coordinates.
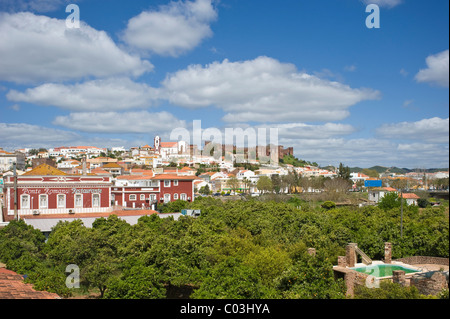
[0,197,449,299]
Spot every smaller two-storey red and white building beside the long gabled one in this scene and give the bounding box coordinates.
[111,171,196,209]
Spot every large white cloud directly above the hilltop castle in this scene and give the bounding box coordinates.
[161,56,380,122]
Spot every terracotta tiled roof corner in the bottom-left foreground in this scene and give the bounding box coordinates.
[0,268,61,299]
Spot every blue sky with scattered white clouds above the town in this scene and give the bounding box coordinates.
[0,0,449,168]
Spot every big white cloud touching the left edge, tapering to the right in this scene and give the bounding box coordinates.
[0,12,153,83]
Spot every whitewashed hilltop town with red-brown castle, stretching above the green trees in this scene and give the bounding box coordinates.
[0,136,449,223]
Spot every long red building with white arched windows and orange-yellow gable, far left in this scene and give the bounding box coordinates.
[2,164,112,221]
